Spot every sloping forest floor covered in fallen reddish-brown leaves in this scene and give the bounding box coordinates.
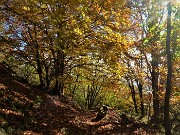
[0,64,160,135]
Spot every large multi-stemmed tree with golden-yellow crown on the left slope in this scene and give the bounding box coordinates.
[0,0,132,96]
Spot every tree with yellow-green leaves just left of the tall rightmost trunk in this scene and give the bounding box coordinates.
[129,0,171,120]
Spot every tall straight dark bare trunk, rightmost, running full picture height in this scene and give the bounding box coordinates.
[164,2,172,135]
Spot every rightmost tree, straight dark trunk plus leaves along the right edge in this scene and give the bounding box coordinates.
[164,1,179,134]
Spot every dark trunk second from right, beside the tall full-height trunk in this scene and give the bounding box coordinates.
[151,53,159,120]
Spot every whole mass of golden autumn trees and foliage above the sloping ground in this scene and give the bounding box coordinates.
[0,0,180,132]
